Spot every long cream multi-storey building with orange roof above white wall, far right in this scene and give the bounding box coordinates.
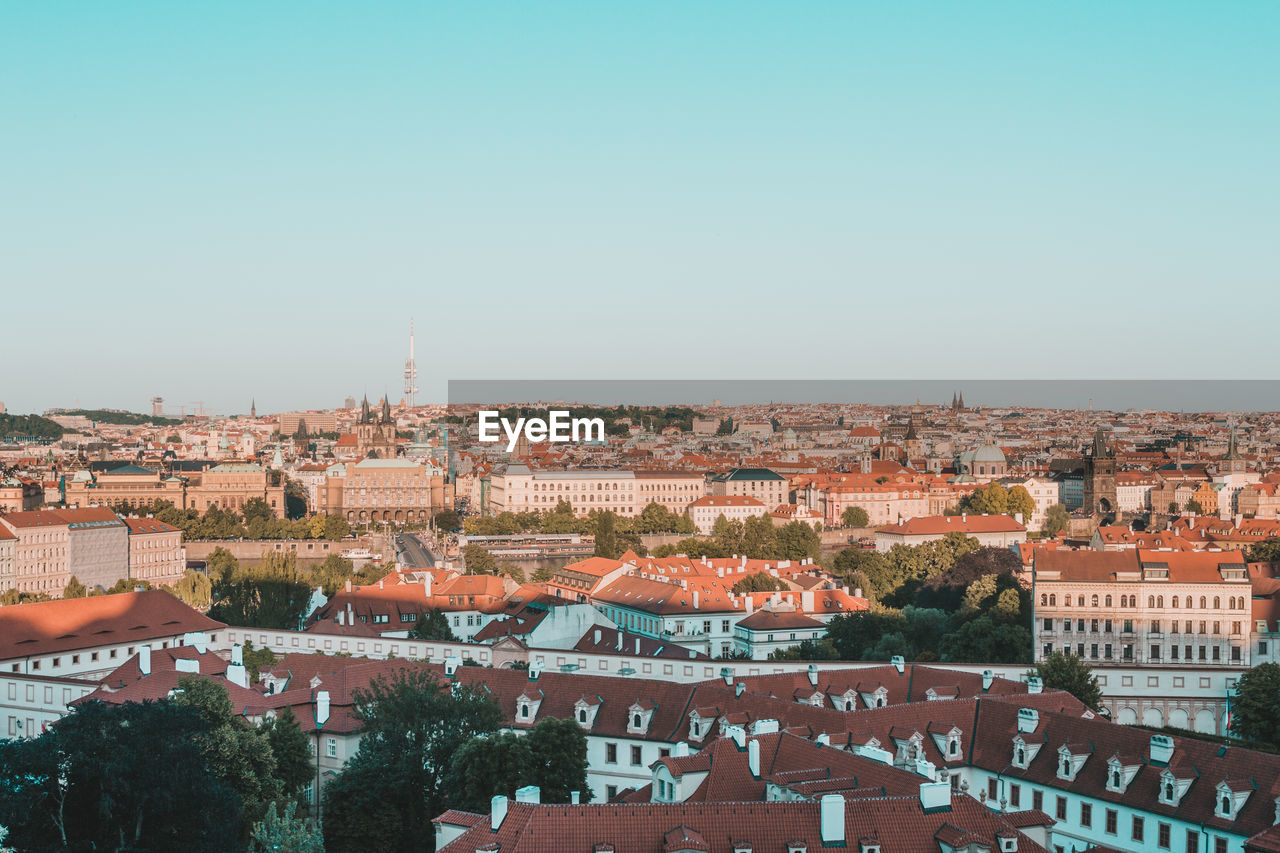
[1033,548,1252,669]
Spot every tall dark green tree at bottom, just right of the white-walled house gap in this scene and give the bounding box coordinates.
[324,667,502,853]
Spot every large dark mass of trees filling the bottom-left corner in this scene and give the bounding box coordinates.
[0,675,314,853]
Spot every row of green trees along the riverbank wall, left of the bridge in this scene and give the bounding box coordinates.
[113,498,351,542]
